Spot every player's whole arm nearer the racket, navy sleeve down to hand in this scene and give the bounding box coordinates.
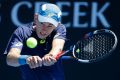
[42,24,66,66]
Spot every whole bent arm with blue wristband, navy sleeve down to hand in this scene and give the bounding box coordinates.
[4,27,42,68]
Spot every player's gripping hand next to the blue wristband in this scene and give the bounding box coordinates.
[26,56,42,69]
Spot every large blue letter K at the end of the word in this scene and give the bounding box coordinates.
[91,2,110,28]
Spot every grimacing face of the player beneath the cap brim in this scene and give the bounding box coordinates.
[36,22,55,39]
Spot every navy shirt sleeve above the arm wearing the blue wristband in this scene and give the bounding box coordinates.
[4,28,23,54]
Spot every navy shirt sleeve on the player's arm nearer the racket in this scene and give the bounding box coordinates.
[54,25,66,40]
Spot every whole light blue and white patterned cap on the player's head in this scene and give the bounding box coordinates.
[38,3,62,27]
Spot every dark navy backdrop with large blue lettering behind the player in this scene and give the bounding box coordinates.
[0,0,120,80]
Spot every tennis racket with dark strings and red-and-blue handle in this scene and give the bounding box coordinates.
[56,29,118,63]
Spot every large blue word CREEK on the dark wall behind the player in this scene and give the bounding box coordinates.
[10,1,110,28]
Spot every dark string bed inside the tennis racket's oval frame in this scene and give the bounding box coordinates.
[75,34,114,60]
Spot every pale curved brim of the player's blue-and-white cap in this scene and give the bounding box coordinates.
[38,15,58,27]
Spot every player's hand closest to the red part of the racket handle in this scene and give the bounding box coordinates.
[42,54,57,66]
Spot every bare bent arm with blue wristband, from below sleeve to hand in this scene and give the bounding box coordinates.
[6,48,42,68]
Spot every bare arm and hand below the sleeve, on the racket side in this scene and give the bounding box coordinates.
[42,39,65,66]
